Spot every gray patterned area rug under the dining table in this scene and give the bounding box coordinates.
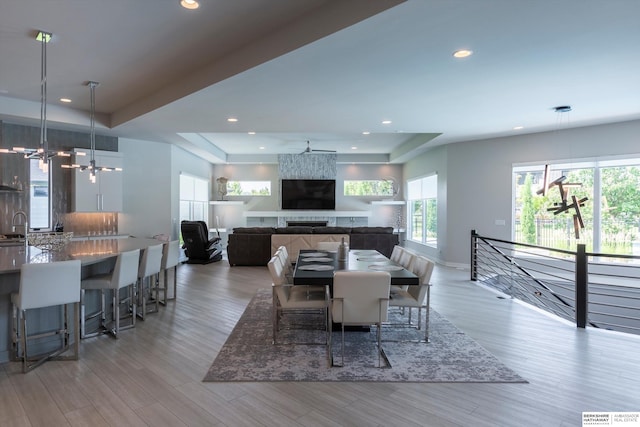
[203,289,527,383]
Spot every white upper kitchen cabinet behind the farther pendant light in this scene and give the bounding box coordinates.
[72,149,123,212]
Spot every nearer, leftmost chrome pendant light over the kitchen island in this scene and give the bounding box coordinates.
[12,31,79,173]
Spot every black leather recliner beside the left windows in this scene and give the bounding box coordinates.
[180,221,222,264]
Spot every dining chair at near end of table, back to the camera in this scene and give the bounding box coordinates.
[329,271,391,368]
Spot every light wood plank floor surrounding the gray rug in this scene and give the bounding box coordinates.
[0,261,640,427]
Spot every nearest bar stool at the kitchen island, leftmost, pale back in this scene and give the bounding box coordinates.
[11,260,81,372]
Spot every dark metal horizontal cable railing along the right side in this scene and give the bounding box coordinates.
[471,231,640,334]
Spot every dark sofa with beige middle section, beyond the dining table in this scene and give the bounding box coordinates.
[227,226,399,266]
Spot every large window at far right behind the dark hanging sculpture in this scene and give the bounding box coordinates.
[513,159,640,255]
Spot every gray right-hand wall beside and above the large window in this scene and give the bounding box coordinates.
[404,121,640,267]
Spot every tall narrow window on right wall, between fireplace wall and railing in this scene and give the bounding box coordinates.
[407,175,438,247]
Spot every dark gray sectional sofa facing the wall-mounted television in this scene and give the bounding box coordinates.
[227,227,399,266]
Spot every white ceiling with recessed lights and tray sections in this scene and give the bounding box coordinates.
[0,0,640,162]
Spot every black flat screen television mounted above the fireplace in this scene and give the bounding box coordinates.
[280,179,336,210]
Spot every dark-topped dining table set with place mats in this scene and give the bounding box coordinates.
[293,249,420,287]
